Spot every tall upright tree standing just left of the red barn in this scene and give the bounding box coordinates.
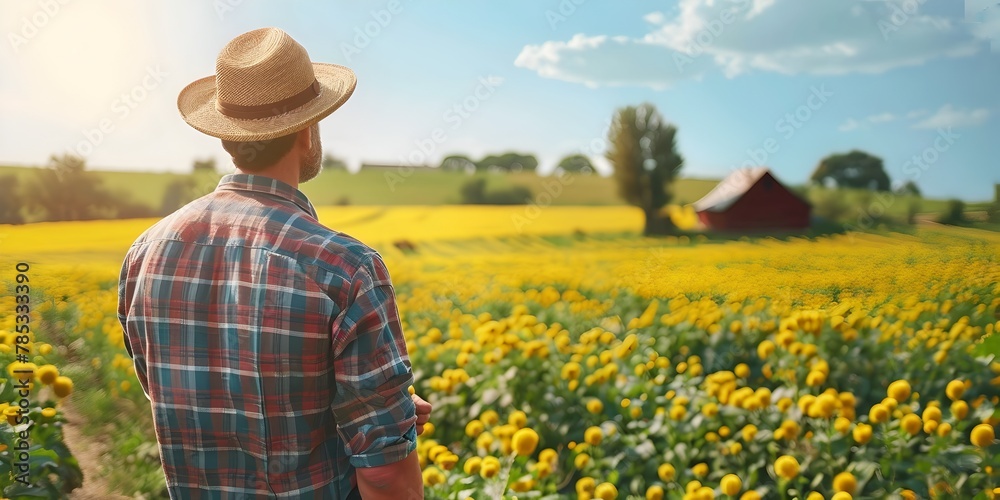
[606,103,684,235]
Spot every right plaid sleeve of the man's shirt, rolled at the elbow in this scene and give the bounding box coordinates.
[331,256,417,467]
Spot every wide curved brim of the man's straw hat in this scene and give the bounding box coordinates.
[177,63,358,142]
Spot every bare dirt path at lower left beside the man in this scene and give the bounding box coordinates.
[62,401,130,500]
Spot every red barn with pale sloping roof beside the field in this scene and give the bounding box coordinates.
[694,167,812,231]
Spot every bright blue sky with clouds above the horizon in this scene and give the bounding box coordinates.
[0,0,1000,200]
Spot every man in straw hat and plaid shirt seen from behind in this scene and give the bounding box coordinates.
[118,28,430,500]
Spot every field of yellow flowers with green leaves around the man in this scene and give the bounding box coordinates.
[0,207,1000,499]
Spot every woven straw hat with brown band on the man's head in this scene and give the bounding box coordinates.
[177,28,357,142]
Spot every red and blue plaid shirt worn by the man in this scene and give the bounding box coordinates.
[118,174,416,499]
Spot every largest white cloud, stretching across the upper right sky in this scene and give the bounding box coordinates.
[515,0,983,88]
